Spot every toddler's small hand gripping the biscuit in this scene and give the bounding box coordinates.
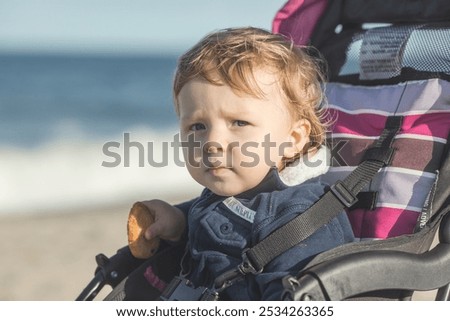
[142,200,186,242]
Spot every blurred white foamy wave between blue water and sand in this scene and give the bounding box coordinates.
[0,129,201,215]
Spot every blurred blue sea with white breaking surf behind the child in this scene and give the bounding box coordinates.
[0,54,201,216]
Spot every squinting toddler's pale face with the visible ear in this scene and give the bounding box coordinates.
[178,71,309,196]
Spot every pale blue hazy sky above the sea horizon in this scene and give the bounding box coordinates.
[0,0,286,54]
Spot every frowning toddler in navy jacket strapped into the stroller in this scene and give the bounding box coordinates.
[139,28,353,300]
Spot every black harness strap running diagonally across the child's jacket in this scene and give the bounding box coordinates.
[216,116,403,288]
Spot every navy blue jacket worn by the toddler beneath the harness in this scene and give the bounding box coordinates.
[178,170,354,300]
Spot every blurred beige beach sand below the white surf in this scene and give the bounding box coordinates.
[0,203,433,301]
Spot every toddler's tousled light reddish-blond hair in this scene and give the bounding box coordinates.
[173,27,326,153]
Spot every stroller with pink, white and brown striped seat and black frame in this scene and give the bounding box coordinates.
[77,0,450,300]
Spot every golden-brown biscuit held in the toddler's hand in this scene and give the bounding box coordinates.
[127,202,159,259]
